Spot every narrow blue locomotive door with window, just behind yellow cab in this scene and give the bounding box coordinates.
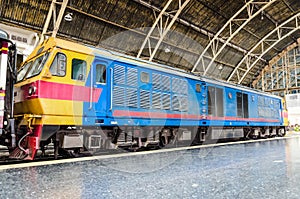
[92,60,108,117]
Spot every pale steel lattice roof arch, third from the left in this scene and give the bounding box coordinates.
[192,0,276,75]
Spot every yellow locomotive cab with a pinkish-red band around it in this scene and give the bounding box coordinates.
[15,38,93,125]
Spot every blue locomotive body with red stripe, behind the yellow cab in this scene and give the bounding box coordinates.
[83,51,284,145]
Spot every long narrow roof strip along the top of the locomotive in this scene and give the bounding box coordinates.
[48,38,282,99]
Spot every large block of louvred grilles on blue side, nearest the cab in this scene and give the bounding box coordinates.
[113,65,189,112]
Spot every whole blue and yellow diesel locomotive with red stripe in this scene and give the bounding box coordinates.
[0,34,285,160]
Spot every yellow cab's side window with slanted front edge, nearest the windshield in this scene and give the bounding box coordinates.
[50,53,67,77]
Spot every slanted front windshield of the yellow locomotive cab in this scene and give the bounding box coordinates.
[17,53,49,82]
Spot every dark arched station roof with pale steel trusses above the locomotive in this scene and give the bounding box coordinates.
[0,0,300,85]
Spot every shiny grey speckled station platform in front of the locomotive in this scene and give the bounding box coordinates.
[0,134,300,199]
